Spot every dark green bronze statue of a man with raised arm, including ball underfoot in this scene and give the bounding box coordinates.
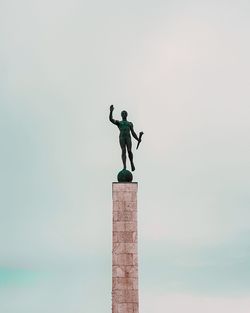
[109,105,143,182]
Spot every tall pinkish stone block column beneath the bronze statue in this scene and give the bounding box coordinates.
[112,183,139,313]
